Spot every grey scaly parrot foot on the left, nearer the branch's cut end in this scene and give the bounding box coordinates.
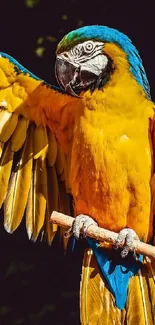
[65,214,97,239]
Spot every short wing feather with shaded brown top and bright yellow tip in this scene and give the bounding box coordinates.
[34,126,48,160]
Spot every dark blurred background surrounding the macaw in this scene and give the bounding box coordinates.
[0,0,155,325]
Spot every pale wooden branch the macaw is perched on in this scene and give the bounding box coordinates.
[50,211,155,259]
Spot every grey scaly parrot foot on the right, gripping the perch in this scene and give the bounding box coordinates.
[115,228,139,258]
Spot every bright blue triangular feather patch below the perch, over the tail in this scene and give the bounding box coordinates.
[87,238,143,309]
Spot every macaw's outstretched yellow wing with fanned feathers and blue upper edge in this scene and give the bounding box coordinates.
[0,53,77,243]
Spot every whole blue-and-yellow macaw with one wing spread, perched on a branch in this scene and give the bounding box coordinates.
[0,26,155,325]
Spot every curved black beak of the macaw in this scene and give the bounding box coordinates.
[55,57,80,97]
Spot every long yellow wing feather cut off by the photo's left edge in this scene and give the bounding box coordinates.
[0,142,14,207]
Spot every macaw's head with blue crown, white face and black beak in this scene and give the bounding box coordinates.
[55,25,150,98]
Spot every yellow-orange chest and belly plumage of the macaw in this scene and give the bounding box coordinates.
[70,73,154,236]
